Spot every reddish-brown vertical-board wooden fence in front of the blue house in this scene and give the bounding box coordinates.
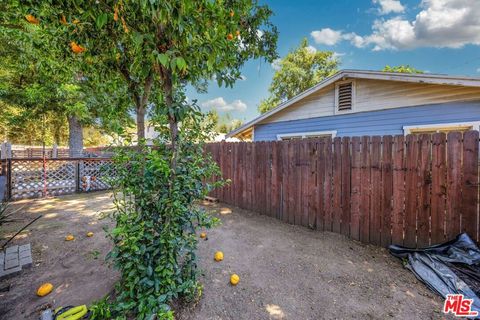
[207,131,479,247]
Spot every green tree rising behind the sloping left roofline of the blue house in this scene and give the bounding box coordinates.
[258,39,339,113]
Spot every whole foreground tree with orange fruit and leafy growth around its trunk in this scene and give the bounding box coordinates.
[10,0,277,319]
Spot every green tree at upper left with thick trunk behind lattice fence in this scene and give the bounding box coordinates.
[0,1,131,156]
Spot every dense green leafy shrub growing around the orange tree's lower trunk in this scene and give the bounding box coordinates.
[95,106,222,319]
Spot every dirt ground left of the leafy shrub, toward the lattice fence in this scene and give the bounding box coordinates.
[0,193,118,320]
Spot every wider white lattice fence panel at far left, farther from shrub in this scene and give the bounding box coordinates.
[11,160,76,200]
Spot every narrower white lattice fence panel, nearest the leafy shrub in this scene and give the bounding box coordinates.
[79,159,115,191]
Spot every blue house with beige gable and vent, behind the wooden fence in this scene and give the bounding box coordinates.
[227,70,480,141]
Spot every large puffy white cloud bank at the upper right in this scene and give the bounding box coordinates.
[312,0,480,51]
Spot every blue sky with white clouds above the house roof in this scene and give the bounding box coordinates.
[187,0,480,122]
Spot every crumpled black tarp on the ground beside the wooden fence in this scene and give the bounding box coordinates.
[389,233,480,314]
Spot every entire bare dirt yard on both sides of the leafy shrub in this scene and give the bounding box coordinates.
[0,193,443,320]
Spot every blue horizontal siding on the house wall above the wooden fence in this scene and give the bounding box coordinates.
[254,101,480,141]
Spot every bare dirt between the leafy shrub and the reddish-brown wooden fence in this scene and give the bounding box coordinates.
[180,204,443,320]
